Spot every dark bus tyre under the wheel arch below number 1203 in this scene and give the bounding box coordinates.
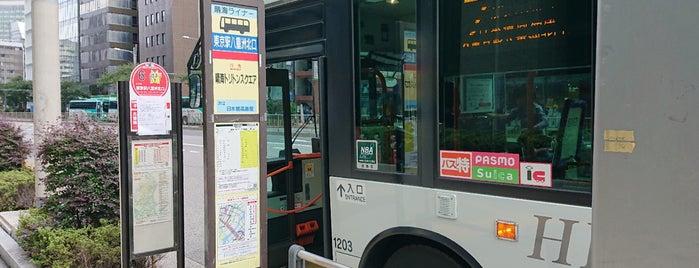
[383,244,463,268]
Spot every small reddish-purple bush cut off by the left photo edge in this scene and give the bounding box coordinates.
[0,120,30,171]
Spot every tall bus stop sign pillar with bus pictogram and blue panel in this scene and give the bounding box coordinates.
[199,0,267,267]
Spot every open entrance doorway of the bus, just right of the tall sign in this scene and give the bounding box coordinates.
[265,59,323,267]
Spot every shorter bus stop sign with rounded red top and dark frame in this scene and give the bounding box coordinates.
[118,62,184,267]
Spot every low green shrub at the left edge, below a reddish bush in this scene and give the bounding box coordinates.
[0,169,34,211]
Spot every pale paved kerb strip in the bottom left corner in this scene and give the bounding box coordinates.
[0,211,36,268]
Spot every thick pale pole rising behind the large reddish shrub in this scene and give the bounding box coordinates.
[31,0,61,203]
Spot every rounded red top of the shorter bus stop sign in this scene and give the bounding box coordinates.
[129,62,170,97]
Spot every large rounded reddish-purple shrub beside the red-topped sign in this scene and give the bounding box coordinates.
[37,120,119,228]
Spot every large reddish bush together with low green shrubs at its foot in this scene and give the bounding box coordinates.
[16,120,162,267]
